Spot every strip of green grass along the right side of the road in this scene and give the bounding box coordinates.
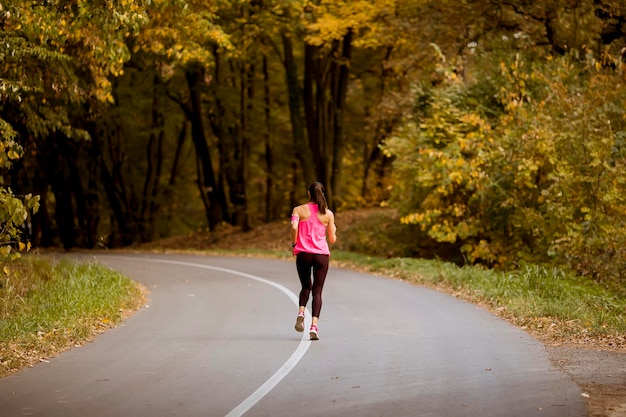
[333,251,626,343]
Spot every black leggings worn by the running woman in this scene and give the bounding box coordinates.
[296,252,330,317]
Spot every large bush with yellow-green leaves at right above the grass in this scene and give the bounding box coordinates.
[385,49,626,279]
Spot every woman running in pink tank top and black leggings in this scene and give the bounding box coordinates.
[291,182,337,340]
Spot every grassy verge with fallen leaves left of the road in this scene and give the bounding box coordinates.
[0,256,144,376]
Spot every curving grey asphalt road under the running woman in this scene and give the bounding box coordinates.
[0,255,586,417]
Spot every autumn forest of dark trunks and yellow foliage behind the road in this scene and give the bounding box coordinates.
[0,0,626,282]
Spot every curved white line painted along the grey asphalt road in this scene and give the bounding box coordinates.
[102,256,311,417]
